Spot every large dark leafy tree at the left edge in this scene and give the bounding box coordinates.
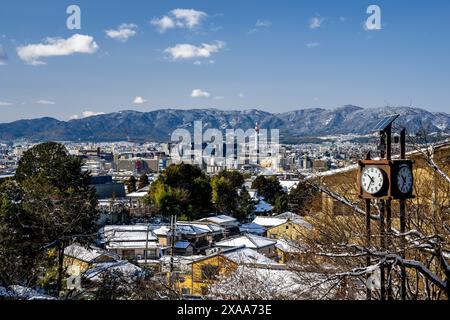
[0,142,98,292]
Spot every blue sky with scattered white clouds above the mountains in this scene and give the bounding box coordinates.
[0,0,450,122]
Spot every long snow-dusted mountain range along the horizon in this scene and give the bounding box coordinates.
[0,105,450,142]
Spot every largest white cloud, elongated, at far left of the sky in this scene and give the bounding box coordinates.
[17,34,98,65]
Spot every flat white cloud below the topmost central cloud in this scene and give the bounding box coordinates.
[164,41,226,60]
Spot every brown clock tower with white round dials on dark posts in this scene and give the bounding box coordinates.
[357,114,414,300]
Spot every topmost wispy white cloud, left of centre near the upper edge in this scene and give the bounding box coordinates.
[150,9,208,33]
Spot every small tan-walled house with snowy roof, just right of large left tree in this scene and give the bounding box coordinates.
[64,244,120,276]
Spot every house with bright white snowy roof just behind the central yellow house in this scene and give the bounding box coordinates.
[216,233,277,258]
